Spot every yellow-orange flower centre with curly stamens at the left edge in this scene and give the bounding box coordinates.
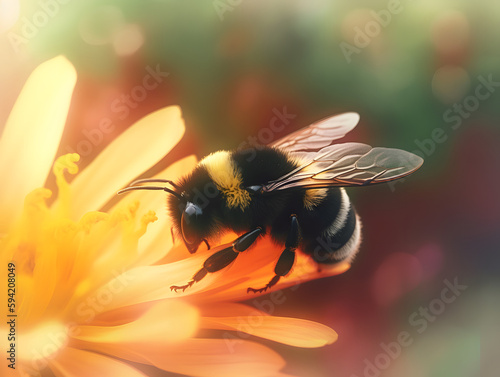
[0,154,157,370]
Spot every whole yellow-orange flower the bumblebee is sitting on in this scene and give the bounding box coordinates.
[0,57,348,376]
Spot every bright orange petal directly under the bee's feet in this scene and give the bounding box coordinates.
[95,238,349,310]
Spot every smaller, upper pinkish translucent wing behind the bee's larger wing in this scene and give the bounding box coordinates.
[270,113,359,153]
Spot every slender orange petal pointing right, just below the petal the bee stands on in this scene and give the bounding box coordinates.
[201,309,338,348]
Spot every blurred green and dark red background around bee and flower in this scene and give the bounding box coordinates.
[0,0,500,377]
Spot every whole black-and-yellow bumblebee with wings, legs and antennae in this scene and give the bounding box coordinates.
[119,113,423,293]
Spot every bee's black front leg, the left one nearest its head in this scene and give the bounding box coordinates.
[170,227,264,292]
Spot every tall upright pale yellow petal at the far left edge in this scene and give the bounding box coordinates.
[0,56,76,233]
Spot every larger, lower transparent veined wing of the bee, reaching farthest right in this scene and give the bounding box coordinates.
[262,143,424,192]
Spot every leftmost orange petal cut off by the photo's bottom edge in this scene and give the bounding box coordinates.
[49,347,147,377]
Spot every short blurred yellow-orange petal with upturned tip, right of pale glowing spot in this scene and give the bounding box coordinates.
[74,300,199,346]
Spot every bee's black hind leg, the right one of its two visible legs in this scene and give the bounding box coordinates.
[247,215,300,293]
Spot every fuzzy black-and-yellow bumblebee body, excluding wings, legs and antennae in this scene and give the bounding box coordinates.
[168,147,360,264]
